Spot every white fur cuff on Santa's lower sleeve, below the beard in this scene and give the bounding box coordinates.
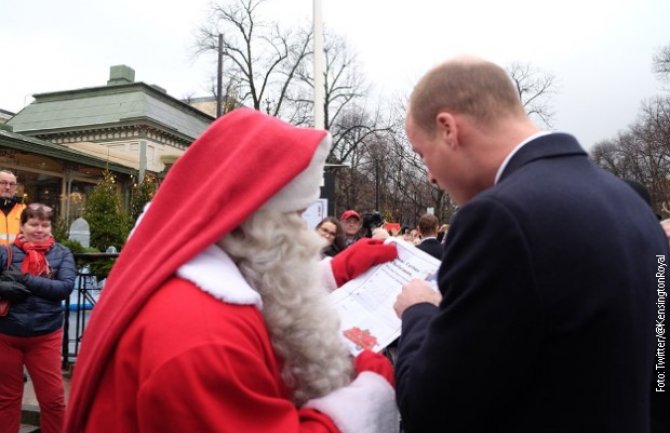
[305,371,400,433]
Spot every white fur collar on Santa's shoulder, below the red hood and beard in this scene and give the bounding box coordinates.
[177,245,263,310]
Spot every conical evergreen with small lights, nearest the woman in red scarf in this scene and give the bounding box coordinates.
[84,170,130,251]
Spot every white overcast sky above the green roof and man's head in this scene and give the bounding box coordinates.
[0,0,670,148]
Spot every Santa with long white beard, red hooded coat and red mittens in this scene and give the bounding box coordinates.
[65,109,399,433]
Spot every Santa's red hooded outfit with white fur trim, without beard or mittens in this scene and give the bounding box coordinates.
[64,109,397,433]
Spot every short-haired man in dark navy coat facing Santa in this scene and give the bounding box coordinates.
[394,58,668,433]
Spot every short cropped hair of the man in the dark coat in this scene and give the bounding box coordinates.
[408,59,525,134]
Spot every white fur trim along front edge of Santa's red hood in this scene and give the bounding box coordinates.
[263,134,332,212]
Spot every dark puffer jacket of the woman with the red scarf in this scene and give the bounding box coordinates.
[0,243,77,337]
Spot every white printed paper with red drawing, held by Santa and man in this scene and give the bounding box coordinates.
[329,238,440,355]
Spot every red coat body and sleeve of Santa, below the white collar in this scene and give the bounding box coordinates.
[85,278,339,433]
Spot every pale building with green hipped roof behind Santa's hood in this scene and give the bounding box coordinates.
[0,65,214,221]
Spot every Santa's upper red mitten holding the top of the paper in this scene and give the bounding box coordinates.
[330,238,398,287]
